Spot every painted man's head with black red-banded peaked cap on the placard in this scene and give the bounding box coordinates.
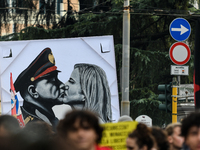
[14,48,65,105]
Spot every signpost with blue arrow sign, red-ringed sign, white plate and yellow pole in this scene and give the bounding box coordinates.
[169,18,191,123]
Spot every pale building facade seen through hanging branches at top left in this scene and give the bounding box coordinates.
[0,0,80,36]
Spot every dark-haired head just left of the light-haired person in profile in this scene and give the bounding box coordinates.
[151,127,169,150]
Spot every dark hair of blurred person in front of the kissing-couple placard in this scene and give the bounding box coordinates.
[57,110,103,143]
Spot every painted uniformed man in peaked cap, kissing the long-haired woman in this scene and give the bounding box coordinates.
[14,48,66,128]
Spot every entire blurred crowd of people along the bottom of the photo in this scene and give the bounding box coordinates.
[0,110,200,150]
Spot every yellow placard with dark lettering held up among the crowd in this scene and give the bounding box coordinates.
[100,121,138,150]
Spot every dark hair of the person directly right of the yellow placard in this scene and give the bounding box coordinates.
[128,123,154,150]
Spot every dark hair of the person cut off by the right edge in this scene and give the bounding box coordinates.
[181,112,200,138]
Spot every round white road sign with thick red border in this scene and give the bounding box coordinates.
[169,42,191,65]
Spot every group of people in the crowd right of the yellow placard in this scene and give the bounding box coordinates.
[126,112,200,150]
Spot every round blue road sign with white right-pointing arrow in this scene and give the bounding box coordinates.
[169,18,191,41]
